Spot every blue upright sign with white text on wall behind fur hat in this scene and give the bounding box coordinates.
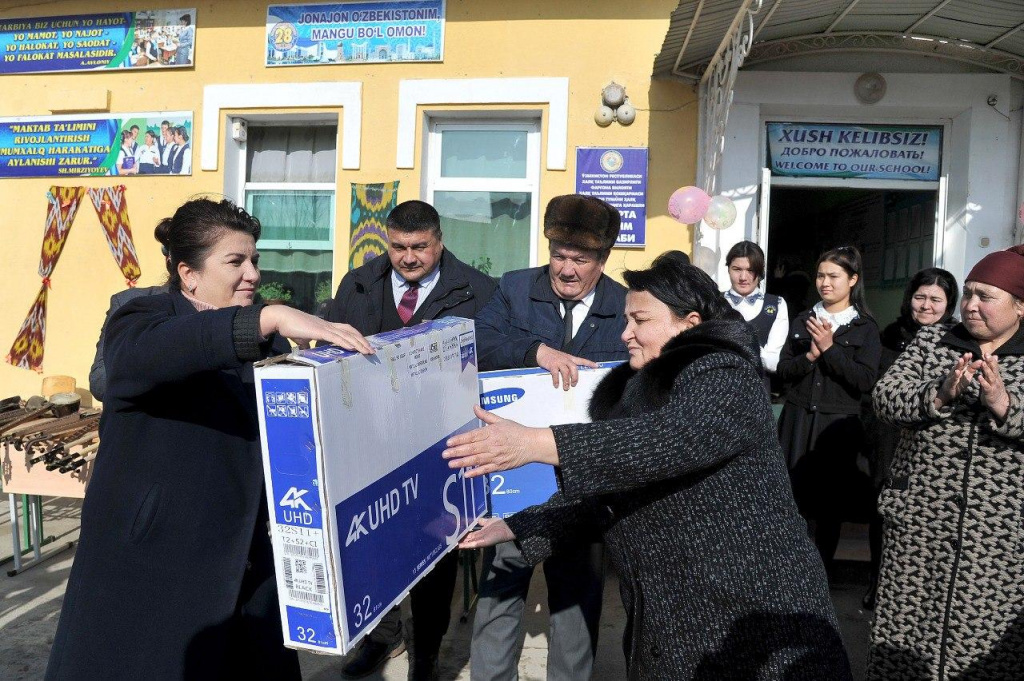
[577,146,647,248]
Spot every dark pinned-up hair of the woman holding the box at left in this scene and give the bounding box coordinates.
[155,199,261,289]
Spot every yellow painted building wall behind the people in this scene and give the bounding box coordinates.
[0,0,697,397]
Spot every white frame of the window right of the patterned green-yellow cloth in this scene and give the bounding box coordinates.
[424,118,541,267]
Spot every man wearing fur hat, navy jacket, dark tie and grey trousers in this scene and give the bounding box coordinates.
[470,195,629,681]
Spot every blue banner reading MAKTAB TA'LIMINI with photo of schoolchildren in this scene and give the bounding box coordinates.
[0,112,193,178]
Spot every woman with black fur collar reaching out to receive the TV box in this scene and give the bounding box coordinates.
[444,251,850,681]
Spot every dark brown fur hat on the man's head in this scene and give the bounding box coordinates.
[544,194,620,251]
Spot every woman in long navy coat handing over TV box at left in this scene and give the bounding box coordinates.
[46,199,372,681]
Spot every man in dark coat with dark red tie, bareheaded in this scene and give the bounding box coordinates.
[325,201,495,681]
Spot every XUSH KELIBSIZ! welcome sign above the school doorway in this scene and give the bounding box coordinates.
[767,122,942,181]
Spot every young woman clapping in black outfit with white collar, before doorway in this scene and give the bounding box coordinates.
[777,246,881,572]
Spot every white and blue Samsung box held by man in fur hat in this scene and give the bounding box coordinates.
[480,361,620,518]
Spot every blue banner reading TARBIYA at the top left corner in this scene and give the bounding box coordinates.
[0,8,196,74]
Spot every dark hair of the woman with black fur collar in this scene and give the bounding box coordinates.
[623,251,742,322]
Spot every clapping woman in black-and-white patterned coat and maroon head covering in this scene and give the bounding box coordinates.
[867,246,1024,681]
